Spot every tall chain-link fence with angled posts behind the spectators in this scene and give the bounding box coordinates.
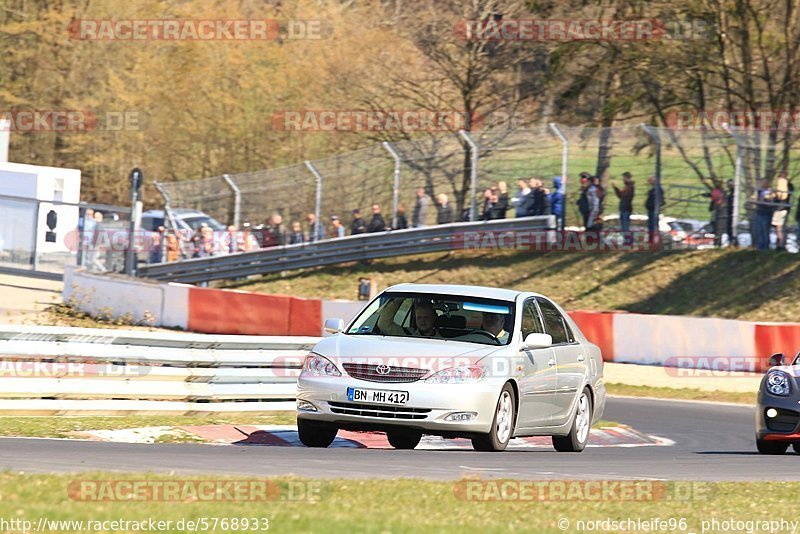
[153,124,798,251]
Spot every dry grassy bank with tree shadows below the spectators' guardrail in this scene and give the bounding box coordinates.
[226,250,800,321]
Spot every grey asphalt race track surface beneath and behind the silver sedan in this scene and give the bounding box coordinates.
[0,398,800,481]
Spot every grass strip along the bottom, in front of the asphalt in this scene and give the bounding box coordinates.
[0,472,800,533]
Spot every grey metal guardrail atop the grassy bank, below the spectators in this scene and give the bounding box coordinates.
[139,215,556,283]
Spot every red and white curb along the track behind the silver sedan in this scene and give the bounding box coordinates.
[72,425,675,450]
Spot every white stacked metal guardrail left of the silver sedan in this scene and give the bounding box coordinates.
[0,325,318,415]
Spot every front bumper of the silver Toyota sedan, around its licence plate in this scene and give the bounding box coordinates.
[297,376,504,437]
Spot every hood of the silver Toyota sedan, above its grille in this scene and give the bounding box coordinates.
[313,334,506,370]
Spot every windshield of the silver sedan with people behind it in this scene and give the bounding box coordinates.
[347,293,514,345]
